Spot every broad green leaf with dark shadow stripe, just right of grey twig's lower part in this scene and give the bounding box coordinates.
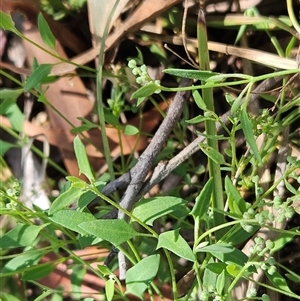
[132,196,186,226]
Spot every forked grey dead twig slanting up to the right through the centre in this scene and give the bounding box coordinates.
[102,77,281,279]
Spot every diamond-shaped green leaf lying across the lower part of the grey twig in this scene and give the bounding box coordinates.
[79,219,139,246]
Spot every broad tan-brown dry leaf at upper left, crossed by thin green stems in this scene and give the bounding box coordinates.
[24,22,93,176]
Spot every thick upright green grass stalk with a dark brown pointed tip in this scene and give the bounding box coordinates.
[197,10,225,239]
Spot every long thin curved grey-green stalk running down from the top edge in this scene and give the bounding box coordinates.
[96,0,120,181]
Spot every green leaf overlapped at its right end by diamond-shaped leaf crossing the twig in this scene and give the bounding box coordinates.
[49,210,96,235]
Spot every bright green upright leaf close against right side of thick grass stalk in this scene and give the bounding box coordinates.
[225,176,247,217]
